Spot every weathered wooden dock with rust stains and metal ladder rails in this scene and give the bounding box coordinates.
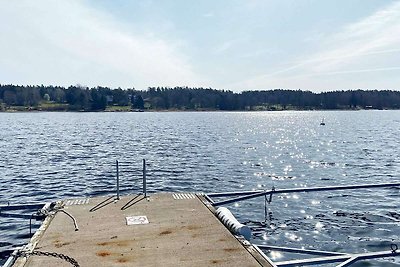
[14,193,273,267]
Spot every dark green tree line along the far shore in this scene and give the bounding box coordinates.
[0,85,400,111]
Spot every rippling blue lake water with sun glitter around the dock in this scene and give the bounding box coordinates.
[0,111,400,267]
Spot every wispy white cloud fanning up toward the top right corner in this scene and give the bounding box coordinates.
[230,2,400,90]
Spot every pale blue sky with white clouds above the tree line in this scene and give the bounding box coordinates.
[0,0,400,92]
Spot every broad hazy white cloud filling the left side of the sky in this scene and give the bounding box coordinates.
[0,0,202,89]
